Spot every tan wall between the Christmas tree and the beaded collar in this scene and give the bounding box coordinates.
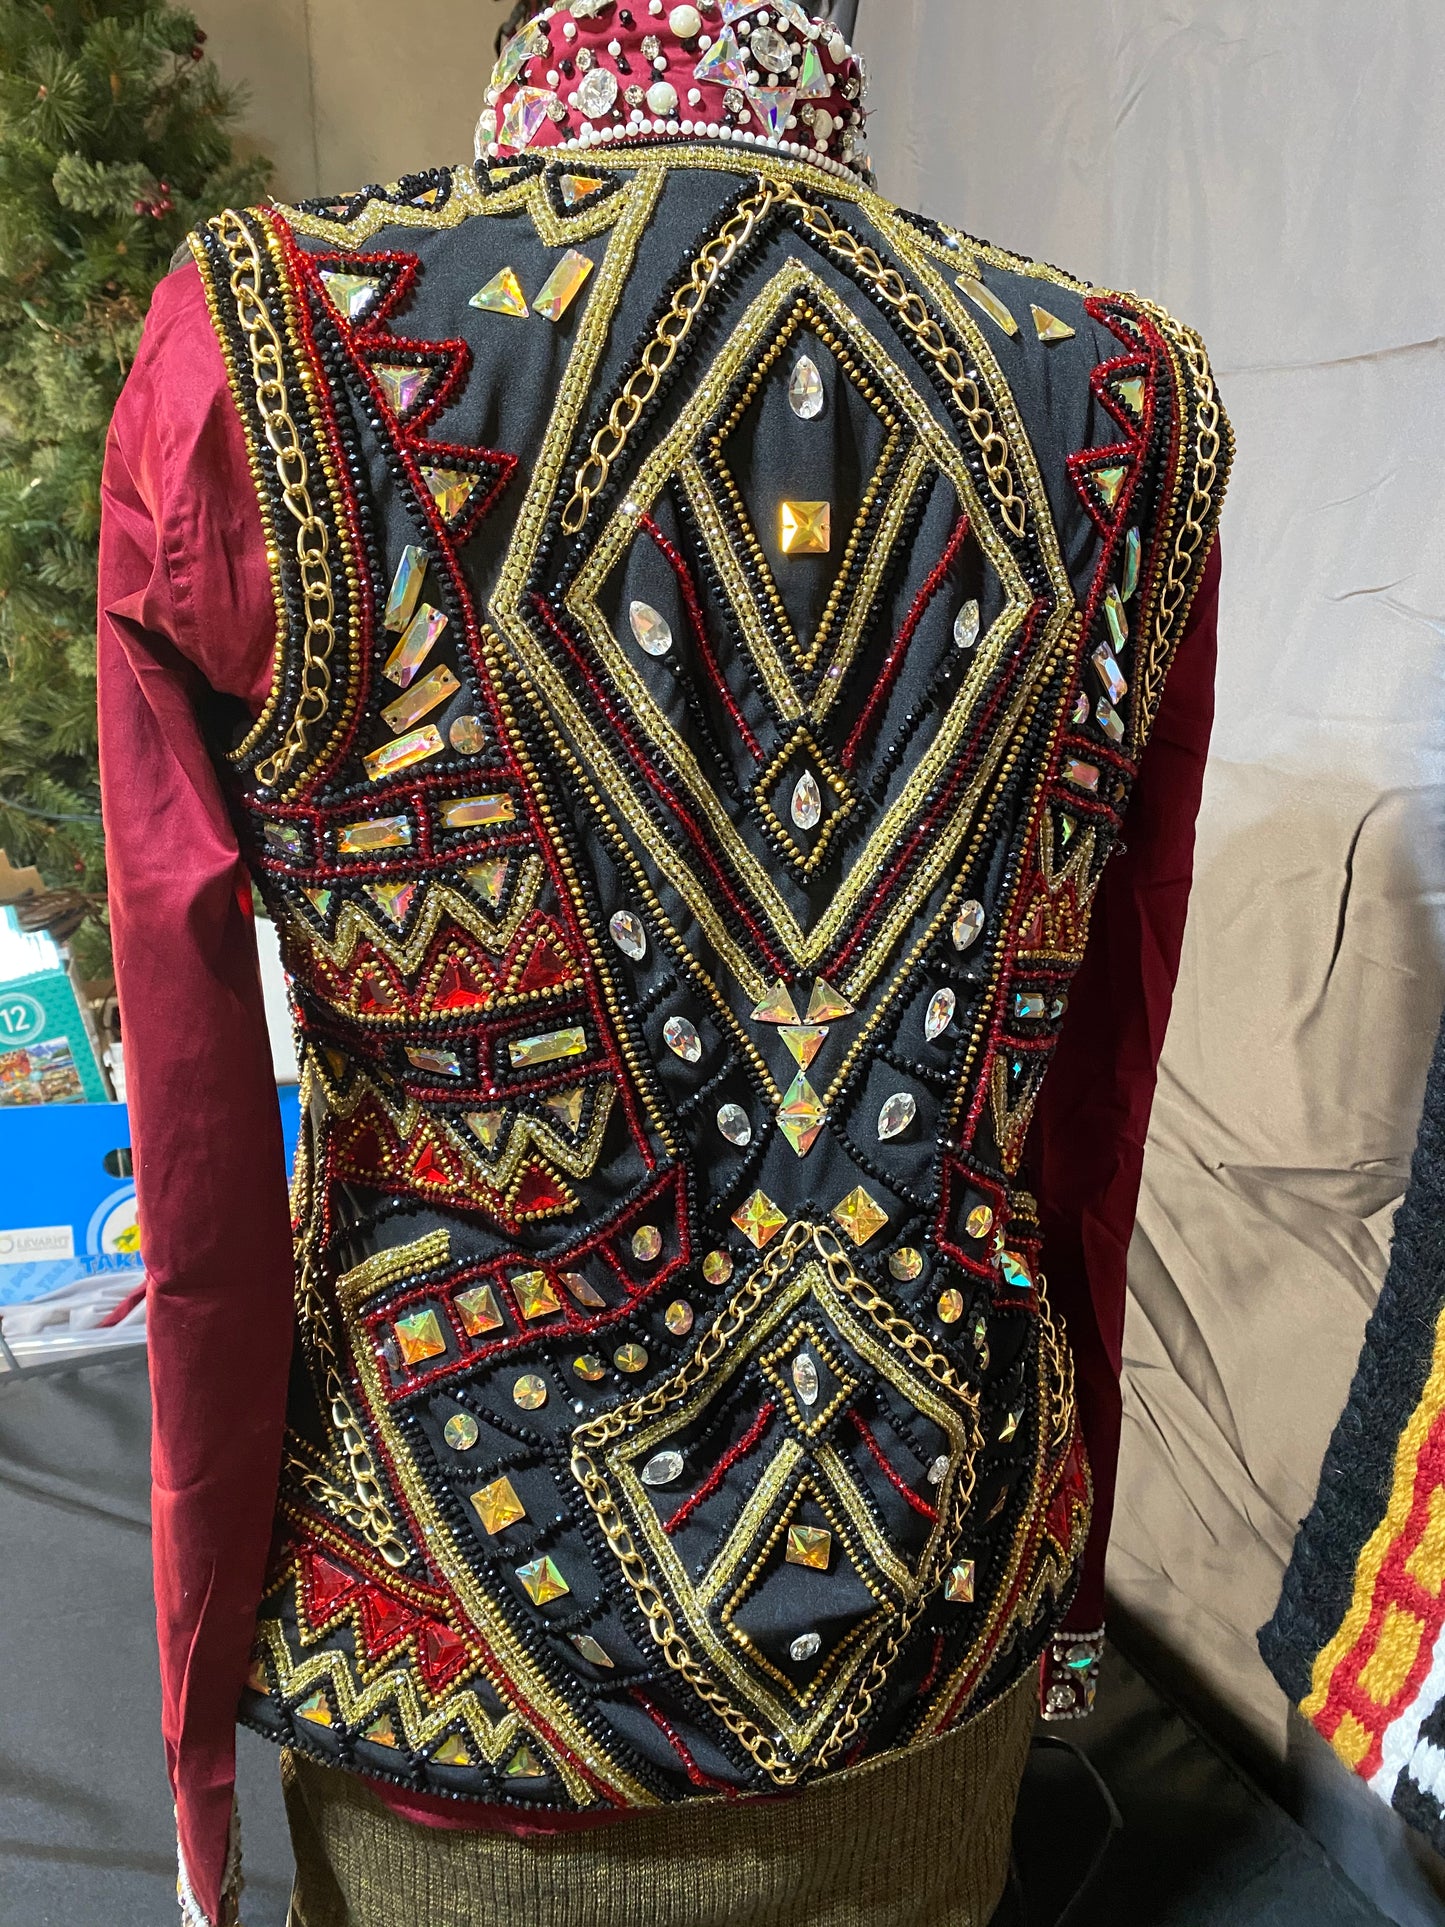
[197,0,511,200]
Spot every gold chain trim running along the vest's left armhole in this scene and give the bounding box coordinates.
[210,210,335,788]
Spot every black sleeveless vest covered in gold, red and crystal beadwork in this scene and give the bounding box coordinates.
[193,143,1229,1811]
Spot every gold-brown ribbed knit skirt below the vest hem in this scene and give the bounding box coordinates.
[281,1678,1037,1927]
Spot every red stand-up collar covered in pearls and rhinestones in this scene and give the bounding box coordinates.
[476,0,869,177]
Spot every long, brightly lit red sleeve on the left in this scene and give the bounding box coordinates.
[98,268,293,1923]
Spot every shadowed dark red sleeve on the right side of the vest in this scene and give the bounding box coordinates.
[1029,543,1220,1632]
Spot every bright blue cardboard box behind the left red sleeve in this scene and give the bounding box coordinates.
[0,1086,301,1305]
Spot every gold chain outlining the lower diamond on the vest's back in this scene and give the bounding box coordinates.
[572,1224,983,1786]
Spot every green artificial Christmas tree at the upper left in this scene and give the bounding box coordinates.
[0,0,270,979]
